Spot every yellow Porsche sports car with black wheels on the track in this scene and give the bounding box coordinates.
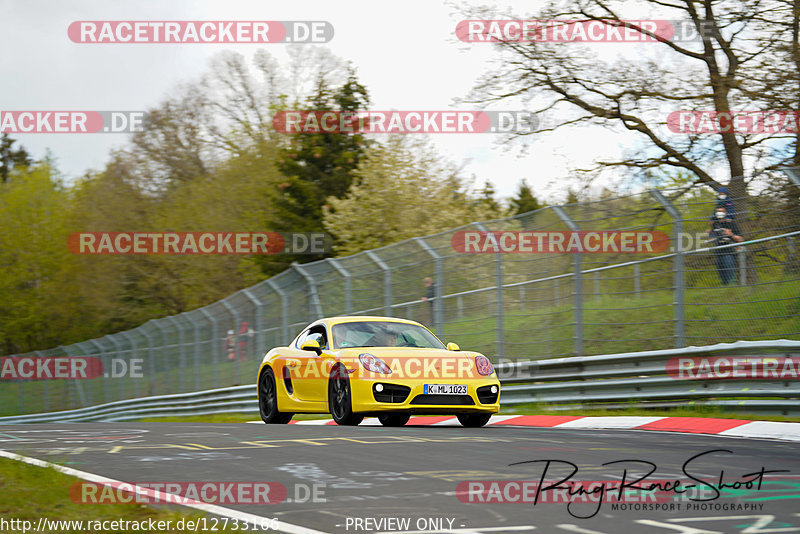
[258,317,500,427]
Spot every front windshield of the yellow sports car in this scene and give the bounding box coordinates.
[333,321,445,349]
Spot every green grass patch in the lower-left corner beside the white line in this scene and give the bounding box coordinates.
[0,458,244,533]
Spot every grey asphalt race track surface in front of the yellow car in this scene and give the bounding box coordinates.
[0,423,800,534]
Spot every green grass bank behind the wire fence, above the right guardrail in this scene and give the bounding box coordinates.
[444,280,800,359]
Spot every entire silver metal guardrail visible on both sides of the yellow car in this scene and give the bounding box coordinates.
[0,340,800,424]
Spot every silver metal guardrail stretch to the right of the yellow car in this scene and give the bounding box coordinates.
[498,340,800,415]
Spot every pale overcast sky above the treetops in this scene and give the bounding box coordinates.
[0,0,704,200]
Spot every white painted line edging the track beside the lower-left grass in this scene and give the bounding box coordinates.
[0,449,327,534]
